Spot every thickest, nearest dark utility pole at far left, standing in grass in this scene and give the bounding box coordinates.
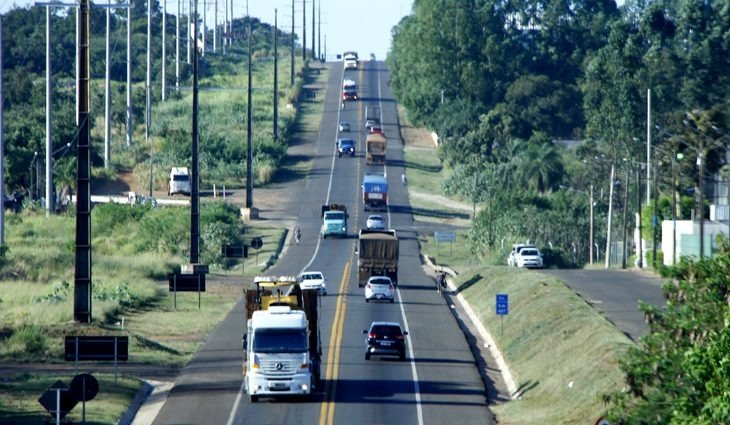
[74,0,92,323]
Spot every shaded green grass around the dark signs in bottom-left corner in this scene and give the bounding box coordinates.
[0,373,142,425]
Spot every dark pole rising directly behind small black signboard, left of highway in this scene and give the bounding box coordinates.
[190,0,199,264]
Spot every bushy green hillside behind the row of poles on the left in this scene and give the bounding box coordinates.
[3,0,302,198]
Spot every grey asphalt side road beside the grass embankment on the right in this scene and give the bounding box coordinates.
[543,270,665,341]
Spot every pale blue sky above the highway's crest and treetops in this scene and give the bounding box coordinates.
[0,0,413,60]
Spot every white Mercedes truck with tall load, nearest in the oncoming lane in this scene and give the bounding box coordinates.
[242,276,322,403]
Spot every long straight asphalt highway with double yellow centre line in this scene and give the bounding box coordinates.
[154,61,494,425]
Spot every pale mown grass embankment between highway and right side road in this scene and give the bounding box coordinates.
[398,110,632,424]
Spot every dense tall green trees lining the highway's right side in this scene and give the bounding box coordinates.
[388,0,730,264]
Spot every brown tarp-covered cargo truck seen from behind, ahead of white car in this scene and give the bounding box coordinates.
[357,229,398,287]
